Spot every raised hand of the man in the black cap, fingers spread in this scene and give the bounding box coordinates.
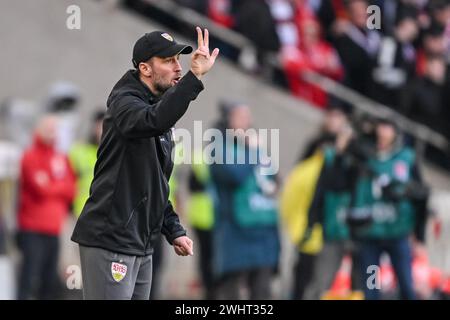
[191,27,219,79]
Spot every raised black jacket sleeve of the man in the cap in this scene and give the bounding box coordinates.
[110,71,203,138]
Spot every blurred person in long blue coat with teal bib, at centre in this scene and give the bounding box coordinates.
[211,102,280,300]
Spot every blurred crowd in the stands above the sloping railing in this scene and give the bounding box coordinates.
[167,0,450,169]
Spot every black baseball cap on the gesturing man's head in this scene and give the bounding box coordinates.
[132,31,192,68]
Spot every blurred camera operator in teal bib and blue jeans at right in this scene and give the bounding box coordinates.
[334,119,428,299]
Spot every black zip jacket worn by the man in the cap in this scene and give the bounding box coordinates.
[72,70,203,256]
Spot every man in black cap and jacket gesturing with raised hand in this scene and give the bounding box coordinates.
[72,27,219,299]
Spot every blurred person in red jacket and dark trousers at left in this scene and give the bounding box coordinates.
[17,115,75,299]
